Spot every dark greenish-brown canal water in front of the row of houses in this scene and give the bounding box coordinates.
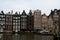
[0,33,53,40]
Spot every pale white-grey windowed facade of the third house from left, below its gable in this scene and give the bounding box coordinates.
[13,16,20,32]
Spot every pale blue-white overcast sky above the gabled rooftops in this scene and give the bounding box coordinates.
[0,0,60,15]
